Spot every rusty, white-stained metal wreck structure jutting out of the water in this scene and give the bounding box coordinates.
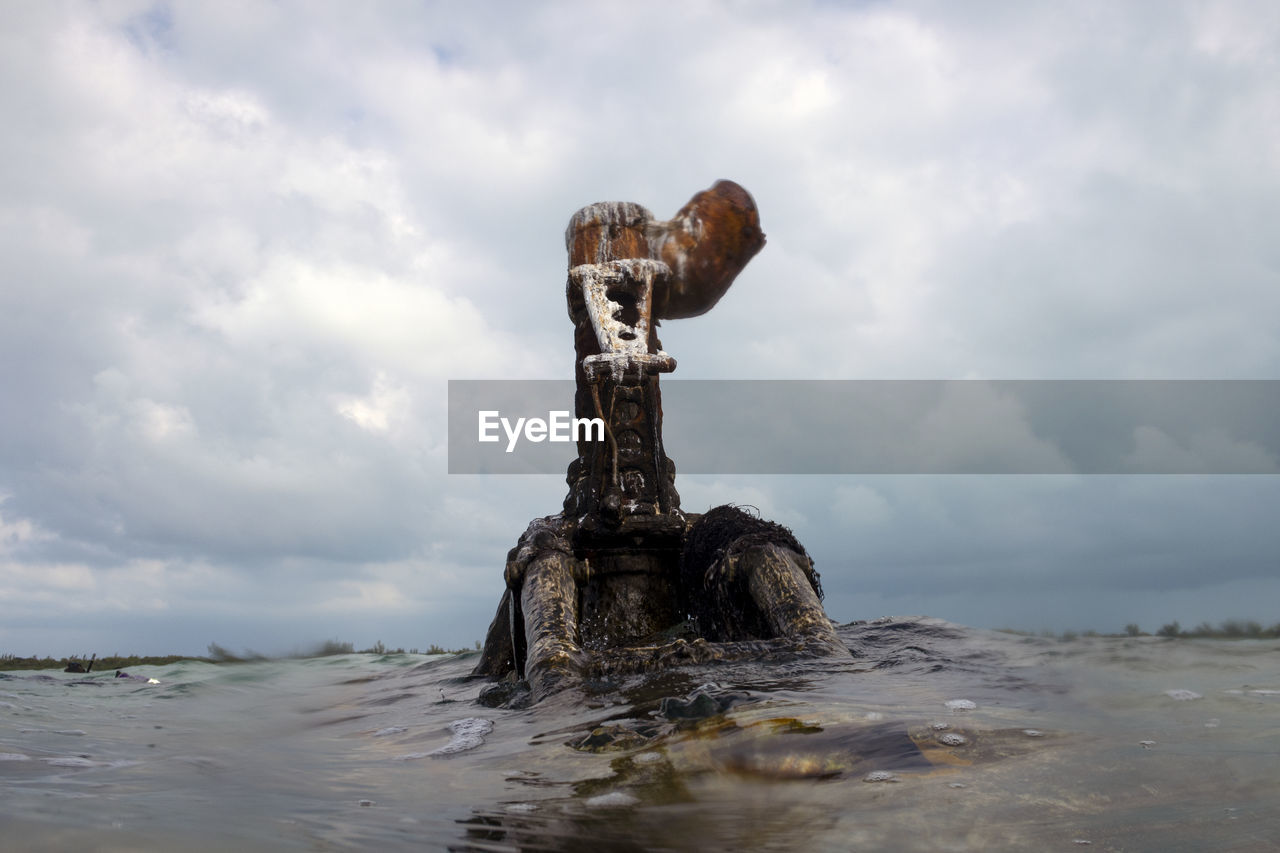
[474,181,847,701]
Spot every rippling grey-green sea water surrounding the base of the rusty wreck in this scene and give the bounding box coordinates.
[0,619,1280,852]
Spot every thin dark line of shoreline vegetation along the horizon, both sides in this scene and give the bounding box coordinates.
[0,619,1280,672]
